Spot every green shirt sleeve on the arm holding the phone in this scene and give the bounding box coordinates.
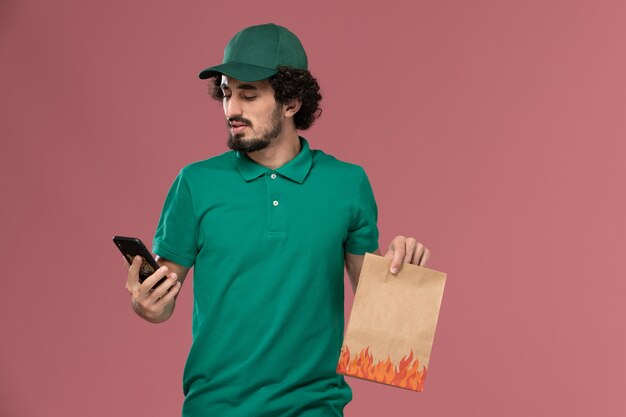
[153,170,198,268]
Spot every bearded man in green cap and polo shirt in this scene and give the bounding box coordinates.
[127,24,429,417]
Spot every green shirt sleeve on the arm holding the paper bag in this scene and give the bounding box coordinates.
[344,169,378,255]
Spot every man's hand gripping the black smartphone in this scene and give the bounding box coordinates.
[126,256,184,323]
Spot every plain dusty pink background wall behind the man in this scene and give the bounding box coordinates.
[0,0,626,417]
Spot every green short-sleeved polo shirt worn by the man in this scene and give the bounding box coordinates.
[154,138,378,417]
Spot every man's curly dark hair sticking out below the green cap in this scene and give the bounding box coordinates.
[209,66,322,130]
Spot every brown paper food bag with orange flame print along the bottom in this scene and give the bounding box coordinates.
[337,253,446,391]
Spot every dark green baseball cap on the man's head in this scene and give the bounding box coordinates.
[198,23,308,82]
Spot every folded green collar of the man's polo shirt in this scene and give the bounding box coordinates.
[234,136,313,184]
